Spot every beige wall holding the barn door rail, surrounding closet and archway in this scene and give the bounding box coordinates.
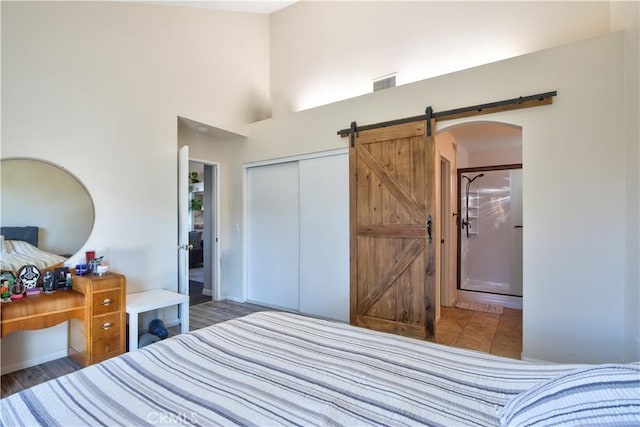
[229,33,637,362]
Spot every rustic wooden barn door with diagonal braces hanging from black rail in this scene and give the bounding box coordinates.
[349,121,437,340]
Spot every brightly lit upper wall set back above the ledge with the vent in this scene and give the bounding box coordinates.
[271,1,609,115]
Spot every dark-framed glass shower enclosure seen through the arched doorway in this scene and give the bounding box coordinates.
[458,165,523,296]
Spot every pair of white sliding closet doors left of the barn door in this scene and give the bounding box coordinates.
[246,152,349,322]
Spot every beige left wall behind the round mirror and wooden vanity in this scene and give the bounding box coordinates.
[1,1,270,370]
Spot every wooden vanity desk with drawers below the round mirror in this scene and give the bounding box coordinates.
[0,272,126,366]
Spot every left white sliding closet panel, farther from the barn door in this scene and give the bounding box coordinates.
[247,162,299,310]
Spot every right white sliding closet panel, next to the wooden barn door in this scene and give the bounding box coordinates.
[300,153,349,322]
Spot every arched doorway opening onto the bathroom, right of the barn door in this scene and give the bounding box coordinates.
[436,121,523,357]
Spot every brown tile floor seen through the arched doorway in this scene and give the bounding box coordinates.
[436,307,522,359]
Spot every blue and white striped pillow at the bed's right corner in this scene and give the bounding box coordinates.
[498,364,640,427]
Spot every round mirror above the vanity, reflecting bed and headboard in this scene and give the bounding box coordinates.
[0,159,95,271]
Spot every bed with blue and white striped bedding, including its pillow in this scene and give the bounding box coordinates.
[0,312,640,426]
